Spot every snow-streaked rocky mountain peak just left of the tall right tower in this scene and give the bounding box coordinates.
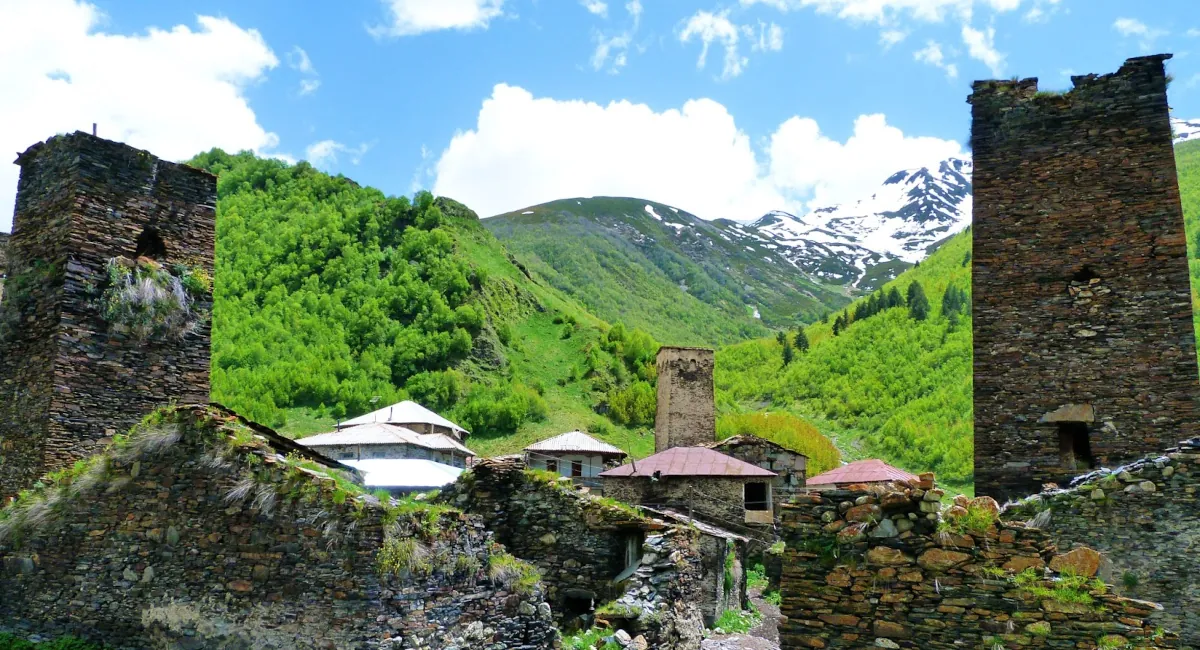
[748,158,972,289]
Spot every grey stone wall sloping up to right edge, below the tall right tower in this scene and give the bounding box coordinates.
[1004,439,1200,648]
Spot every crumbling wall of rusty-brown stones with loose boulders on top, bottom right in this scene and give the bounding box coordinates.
[780,481,1177,650]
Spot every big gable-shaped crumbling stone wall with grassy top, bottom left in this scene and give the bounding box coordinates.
[0,408,557,650]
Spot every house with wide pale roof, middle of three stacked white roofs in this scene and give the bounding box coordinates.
[296,423,475,468]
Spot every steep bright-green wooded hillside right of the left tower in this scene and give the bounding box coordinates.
[192,150,658,456]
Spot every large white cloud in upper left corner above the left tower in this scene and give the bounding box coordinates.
[0,0,278,230]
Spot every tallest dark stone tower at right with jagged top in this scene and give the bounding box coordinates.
[968,54,1200,499]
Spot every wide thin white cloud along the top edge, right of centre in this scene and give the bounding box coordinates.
[740,0,1021,25]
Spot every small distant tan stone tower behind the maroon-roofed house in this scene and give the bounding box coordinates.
[654,347,716,452]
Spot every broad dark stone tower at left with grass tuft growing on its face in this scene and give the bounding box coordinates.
[0,132,216,500]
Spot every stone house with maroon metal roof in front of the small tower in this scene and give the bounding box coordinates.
[600,447,778,534]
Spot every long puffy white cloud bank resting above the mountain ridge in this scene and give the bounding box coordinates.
[433,84,962,218]
